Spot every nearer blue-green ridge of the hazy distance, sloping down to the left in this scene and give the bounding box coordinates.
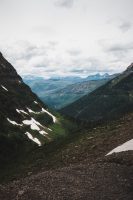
[41,79,108,110]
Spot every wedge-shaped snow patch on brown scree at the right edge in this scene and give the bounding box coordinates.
[107,139,133,156]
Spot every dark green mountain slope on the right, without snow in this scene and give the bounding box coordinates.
[61,64,133,122]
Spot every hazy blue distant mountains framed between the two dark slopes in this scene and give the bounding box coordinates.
[23,73,116,109]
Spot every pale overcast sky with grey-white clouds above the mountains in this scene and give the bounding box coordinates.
[0,0,133,77]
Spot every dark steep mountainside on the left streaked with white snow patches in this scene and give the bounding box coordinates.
[0,54,65,166]
